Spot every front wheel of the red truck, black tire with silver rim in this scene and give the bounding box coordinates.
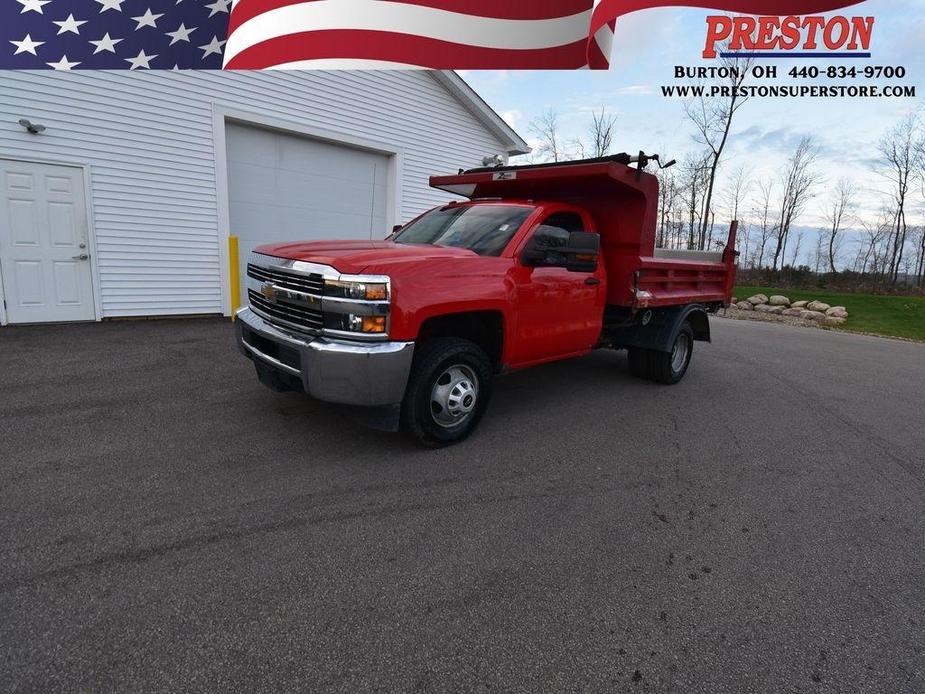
[401,337,492,448]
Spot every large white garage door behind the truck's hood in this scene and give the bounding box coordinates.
[226,123,391,278]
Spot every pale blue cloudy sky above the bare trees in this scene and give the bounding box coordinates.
[460,0,925,262]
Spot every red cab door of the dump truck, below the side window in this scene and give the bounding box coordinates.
[511,210,606,366]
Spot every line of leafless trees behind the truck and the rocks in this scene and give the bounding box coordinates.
[530,66,925,290]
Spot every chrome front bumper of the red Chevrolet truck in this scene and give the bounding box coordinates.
[235,308,414,407]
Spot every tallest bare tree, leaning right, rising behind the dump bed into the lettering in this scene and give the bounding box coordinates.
[684,52,753,249]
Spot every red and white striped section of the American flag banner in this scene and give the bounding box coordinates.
[225,0,859,70]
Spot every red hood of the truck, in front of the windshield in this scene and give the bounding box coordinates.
[255,241,479,274]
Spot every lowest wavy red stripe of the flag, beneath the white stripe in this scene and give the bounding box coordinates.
[225,29,587,70]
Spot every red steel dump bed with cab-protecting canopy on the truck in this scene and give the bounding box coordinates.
[430,159,736,308]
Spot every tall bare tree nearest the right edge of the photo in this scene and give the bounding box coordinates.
[880,114,925,285]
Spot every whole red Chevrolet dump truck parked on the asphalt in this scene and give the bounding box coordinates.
[236,154,736,446]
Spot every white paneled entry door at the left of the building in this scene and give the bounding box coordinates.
[0,159,96,323]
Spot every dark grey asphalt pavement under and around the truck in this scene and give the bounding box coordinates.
[0,320,925,694]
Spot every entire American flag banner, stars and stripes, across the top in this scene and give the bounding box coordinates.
[0,0,858,70]
